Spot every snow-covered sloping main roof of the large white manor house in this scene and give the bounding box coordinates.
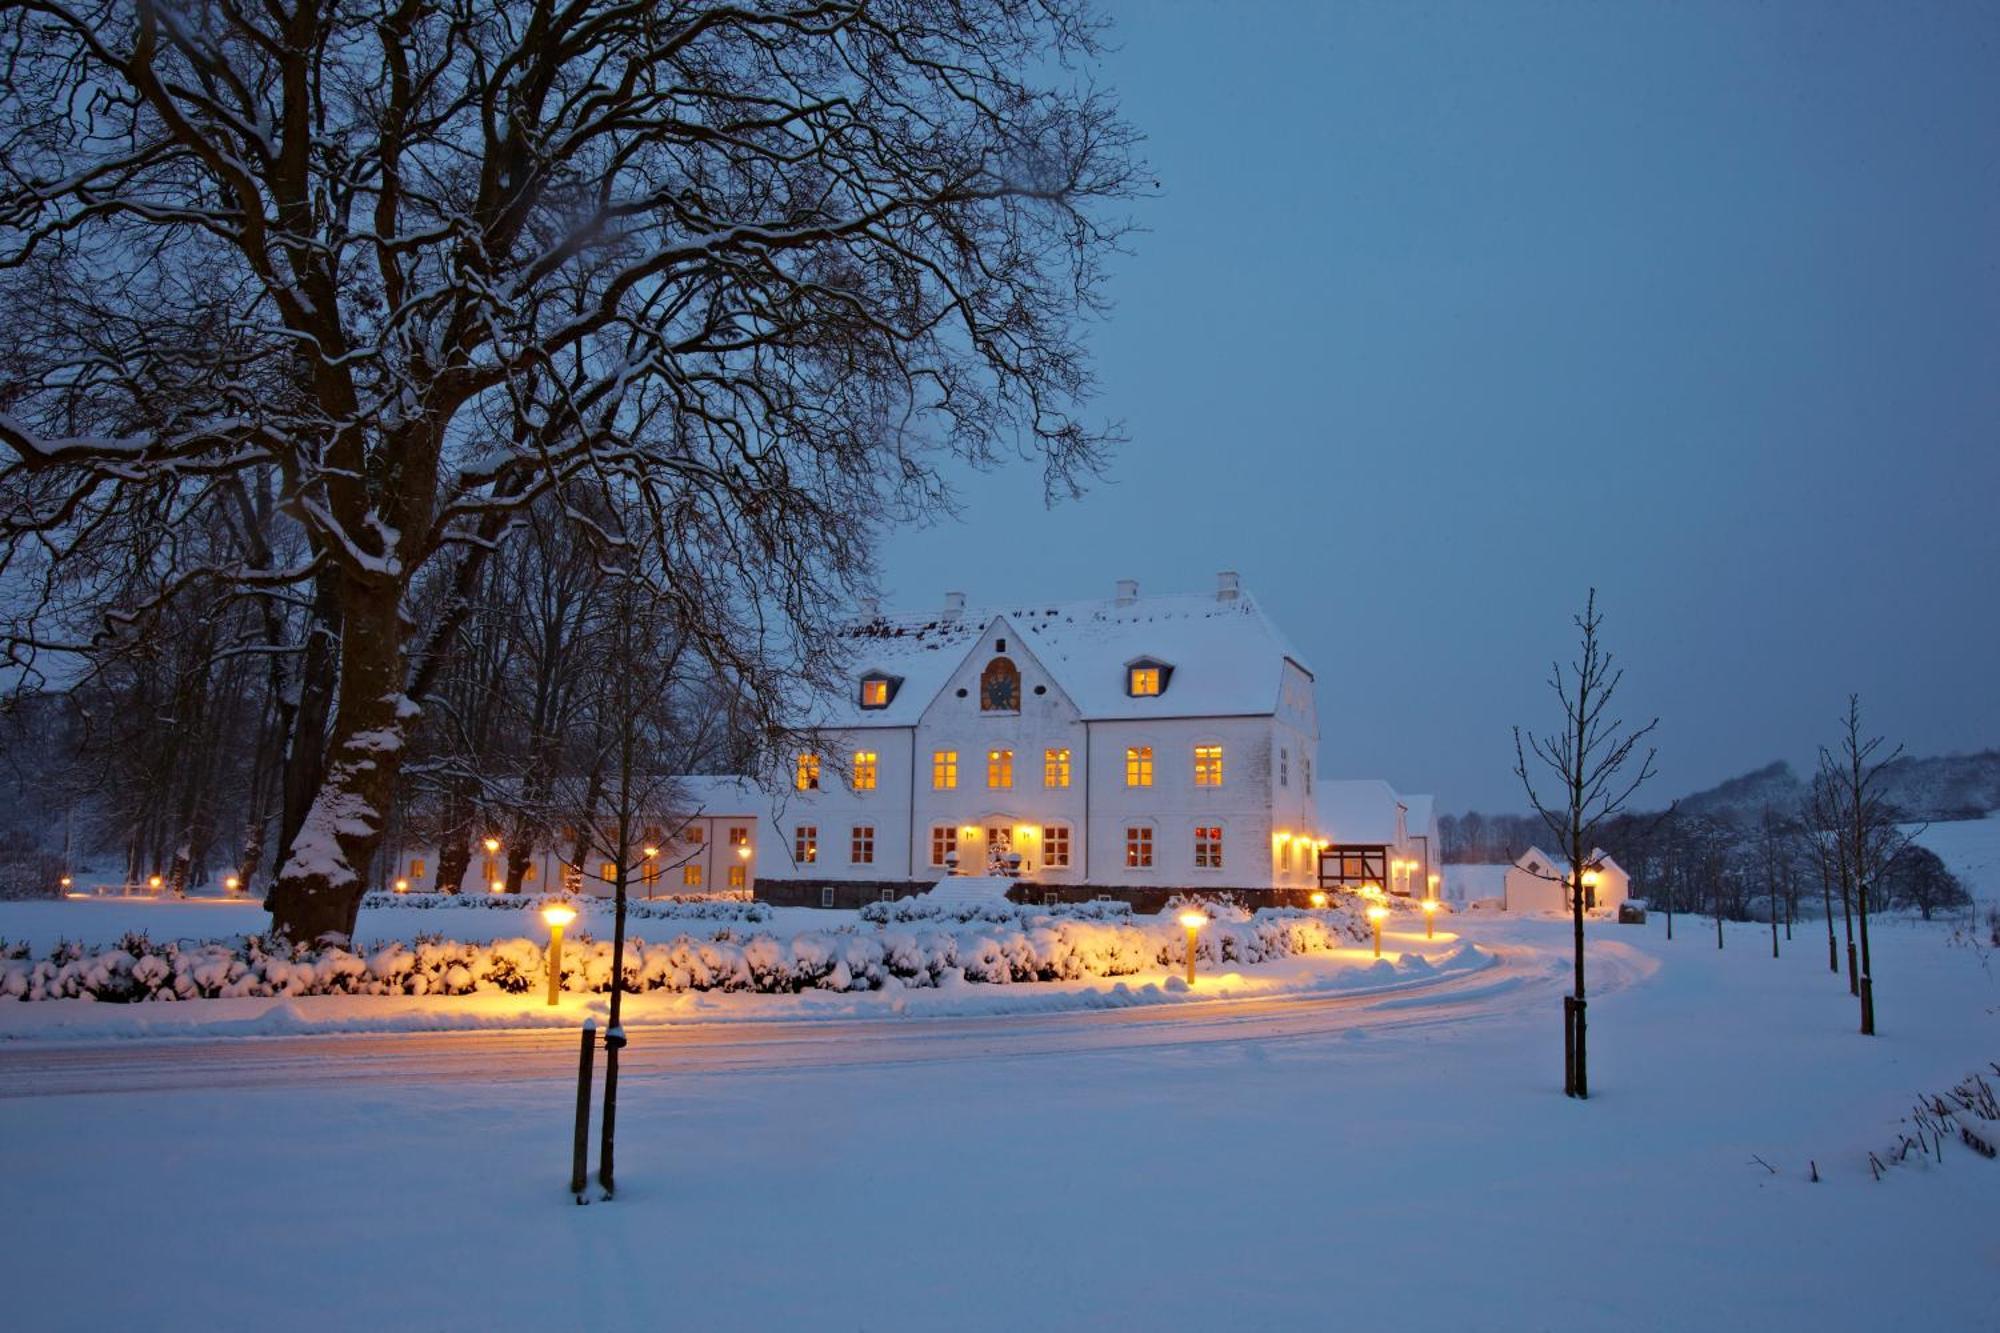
[810,592,1312,727]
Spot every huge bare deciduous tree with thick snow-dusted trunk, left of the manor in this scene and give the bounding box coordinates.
[0,0,1136,939]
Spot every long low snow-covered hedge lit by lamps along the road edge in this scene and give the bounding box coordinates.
[0,911,1368,1003]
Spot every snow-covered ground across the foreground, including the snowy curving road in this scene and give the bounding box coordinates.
[0,915,2000,1329]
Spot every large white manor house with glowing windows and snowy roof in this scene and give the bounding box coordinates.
[756,572,1352,905]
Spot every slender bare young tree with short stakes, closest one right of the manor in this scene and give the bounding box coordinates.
[1514,588,1660,1097]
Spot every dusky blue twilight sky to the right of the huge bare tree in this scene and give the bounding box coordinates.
[884,0,2000,811]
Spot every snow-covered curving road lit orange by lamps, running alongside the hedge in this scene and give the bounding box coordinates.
[0,928,1640,1097]
